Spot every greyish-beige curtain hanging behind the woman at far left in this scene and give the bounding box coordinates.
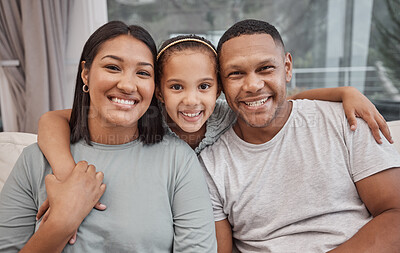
[0,0,74,133]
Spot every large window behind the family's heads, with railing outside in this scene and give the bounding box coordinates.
[107,0,400,120]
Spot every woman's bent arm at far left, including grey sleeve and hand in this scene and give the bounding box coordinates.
[0,145,105,252]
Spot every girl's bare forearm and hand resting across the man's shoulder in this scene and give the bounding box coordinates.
[288,86,393,144]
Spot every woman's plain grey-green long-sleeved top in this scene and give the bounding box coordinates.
[0,136,216,253]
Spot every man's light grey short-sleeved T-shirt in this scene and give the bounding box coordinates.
[200,100,400,253]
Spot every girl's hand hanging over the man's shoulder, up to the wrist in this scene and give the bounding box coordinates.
[342,87,393,144]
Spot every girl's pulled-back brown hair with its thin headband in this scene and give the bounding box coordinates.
[156,34,221,90]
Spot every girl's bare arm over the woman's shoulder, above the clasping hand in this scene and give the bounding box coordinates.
[38,110,75,180]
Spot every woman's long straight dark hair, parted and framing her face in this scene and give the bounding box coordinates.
[69,21,164,145]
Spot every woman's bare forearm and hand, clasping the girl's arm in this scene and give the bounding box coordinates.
[20,162,106,252]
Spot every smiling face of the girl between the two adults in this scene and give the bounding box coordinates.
[156,49,219,133]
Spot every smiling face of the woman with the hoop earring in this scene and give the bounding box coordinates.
[81,35,154,132]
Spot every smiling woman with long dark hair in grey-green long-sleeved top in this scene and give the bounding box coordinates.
[0,21,216,252]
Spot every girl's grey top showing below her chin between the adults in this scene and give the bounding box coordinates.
[159,99,236,155]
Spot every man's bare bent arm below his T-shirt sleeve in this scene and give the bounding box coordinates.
[330,168,400,253]
